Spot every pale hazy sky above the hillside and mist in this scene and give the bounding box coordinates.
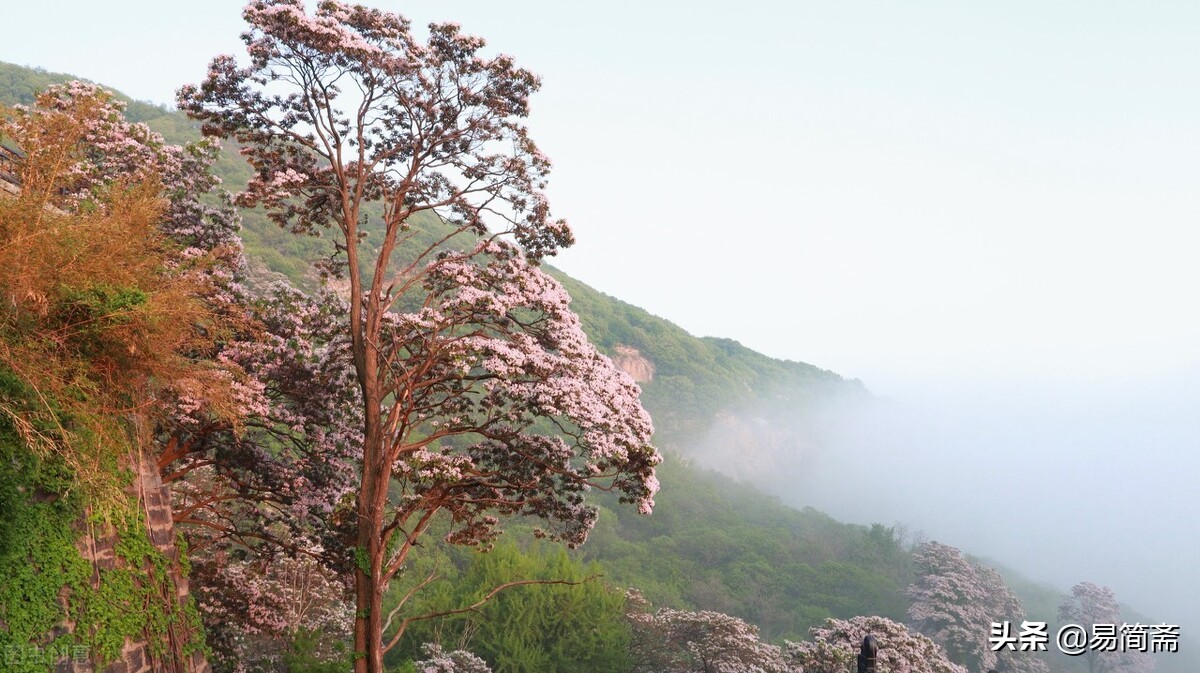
[0,0,1200,647]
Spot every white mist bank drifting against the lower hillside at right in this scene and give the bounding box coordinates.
[698,368,1200,656]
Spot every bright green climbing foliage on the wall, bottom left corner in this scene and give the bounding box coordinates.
[0,383,204,673]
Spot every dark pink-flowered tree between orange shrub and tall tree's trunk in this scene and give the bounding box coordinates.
[158,286,361,561]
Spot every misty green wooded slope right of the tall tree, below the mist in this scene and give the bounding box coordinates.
[583,455,911,641]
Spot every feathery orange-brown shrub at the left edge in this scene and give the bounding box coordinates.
[0,98,238,503]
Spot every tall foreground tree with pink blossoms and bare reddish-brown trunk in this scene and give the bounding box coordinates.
[179,0,660,672]
